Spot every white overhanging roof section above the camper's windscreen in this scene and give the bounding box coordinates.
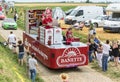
[106,3,120,12]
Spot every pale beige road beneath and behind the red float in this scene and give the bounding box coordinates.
[0,21,113,82]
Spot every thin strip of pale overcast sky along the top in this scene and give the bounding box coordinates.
[6,0,120,2]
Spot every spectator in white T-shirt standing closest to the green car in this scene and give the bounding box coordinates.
[7,31,16,53]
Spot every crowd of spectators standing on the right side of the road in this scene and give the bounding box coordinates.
[87,22,120,72]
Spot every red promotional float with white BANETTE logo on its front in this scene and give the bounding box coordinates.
[23,10,88,69]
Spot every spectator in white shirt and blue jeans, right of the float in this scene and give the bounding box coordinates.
[102,40,110,72]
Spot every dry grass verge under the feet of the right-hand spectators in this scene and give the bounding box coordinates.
[89,60,120,82]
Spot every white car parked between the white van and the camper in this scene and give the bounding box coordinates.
[85,15,109,27]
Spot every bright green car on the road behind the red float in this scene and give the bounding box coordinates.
[2,18,17,30]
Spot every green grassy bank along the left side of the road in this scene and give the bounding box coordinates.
[0,36,44,82]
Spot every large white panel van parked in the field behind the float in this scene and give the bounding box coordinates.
[65,6,104,24]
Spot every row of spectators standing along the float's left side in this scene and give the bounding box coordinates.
[7,31,38,82]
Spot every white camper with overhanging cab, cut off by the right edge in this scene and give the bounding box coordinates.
[103,3,120,33]
